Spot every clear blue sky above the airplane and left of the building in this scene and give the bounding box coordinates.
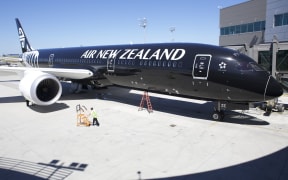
[0,0,247,55]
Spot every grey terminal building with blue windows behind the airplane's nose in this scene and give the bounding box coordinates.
[219,0,288,85]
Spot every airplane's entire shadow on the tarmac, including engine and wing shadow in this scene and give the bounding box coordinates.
[0,83,269,125]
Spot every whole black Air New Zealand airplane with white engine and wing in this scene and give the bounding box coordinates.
[0,18,283,120]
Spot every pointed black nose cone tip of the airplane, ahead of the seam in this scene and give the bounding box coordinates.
[264,76,283,100]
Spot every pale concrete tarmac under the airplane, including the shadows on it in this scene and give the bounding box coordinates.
[0,72,288,180]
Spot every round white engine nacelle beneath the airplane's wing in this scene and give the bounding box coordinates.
[19,71,62,106]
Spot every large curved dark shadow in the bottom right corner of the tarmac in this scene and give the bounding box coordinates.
[146,147,288,180]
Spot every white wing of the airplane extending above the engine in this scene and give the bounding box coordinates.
[0,66,93,79]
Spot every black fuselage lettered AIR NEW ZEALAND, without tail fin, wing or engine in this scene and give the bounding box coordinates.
[23,43,283,103]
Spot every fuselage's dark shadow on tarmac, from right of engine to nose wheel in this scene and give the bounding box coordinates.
[61,87,269,125]
